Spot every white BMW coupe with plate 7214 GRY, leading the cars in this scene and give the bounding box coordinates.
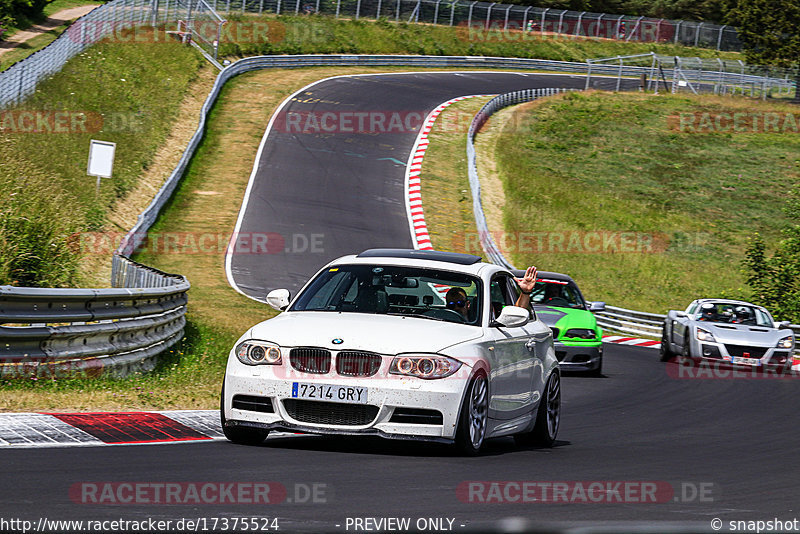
[221,249,561,454]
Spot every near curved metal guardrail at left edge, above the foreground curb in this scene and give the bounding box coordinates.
[0,256,189,379]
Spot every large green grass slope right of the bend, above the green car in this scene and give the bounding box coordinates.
[479,93,800,313]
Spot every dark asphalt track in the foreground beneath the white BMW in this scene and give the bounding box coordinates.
[0,345,800,532]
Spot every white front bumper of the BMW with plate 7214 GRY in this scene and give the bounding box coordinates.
[223,361,468,441]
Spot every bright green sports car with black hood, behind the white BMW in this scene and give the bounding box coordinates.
[514,271,606,376]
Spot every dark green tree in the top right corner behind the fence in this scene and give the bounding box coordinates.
[727,0,800,103]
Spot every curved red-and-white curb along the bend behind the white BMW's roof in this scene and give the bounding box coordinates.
[406,95,490,250]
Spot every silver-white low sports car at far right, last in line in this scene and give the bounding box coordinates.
[661,299,794,372]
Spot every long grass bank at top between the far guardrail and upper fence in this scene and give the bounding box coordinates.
[219,13,741,61]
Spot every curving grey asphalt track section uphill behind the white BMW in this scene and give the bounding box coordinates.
[228,72,638,301]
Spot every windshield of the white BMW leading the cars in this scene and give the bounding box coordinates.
[290,265,482,325]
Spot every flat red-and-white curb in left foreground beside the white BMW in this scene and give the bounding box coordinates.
[0,410,228,449]
